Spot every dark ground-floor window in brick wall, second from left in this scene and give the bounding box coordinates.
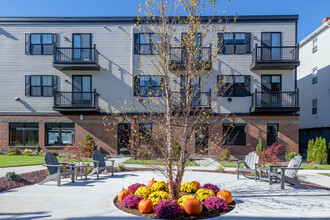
[45,123,75,147]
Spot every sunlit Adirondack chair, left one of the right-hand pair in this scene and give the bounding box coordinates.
[237,152,259,181]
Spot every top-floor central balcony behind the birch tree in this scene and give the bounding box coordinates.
[169,45,212,70]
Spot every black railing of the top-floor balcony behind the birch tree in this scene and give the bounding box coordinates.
[170,45,212,63]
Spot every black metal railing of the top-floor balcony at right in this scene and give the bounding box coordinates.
[252,45,299,62]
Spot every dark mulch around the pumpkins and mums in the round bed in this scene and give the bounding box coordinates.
[113,192,236,220]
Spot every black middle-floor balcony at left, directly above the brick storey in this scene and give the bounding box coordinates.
[53,90,100,112]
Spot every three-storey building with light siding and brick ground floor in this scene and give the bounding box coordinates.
[0,15,299,155]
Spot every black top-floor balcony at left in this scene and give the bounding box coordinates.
[53,45,100,70]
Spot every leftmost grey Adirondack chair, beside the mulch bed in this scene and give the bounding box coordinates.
[40,152,75,186]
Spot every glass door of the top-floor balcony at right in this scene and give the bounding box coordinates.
[261,32,281,60]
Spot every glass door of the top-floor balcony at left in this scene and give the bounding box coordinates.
[72,34,93,61]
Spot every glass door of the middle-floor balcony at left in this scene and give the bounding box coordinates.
[72,76,93,106]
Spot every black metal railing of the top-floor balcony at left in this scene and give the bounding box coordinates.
[54,45,99,63]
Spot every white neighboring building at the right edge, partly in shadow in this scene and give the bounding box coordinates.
[298,17,330,152]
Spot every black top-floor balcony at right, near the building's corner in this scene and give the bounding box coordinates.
[250,45,300,70]
